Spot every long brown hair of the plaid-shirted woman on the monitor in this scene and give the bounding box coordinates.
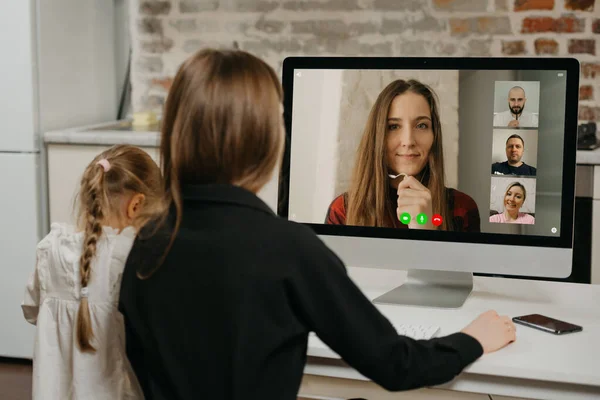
[346,79,452,230]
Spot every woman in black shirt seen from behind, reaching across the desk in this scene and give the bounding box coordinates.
[120,50,515,400]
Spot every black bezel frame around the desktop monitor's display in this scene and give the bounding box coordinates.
[277,57,580,249]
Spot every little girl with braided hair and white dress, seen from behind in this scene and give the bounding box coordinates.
[22,145,163,400]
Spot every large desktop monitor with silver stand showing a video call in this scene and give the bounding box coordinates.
[278,57,579,308]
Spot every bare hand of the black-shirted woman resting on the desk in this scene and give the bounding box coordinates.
[461,310,516,354]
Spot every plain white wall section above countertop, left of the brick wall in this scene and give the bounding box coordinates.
[38,0,118,132]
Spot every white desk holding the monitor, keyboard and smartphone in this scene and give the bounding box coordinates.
[300,268,600,400]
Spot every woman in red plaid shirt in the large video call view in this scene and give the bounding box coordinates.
[325,80,480,232]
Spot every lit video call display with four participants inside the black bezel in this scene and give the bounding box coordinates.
[288,69,566,236]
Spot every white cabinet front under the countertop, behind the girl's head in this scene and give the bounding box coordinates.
[48,144,159,224]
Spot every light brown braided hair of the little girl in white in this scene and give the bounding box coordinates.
[76,145,164,352]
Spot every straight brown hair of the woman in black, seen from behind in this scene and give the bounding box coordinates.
[138,49,285,278]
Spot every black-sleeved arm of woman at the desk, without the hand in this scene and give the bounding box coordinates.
[290,231,483,391]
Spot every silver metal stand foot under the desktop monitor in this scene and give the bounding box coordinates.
[373,269,473,308]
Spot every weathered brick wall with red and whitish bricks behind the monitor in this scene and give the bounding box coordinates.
[131,0,600,121]
